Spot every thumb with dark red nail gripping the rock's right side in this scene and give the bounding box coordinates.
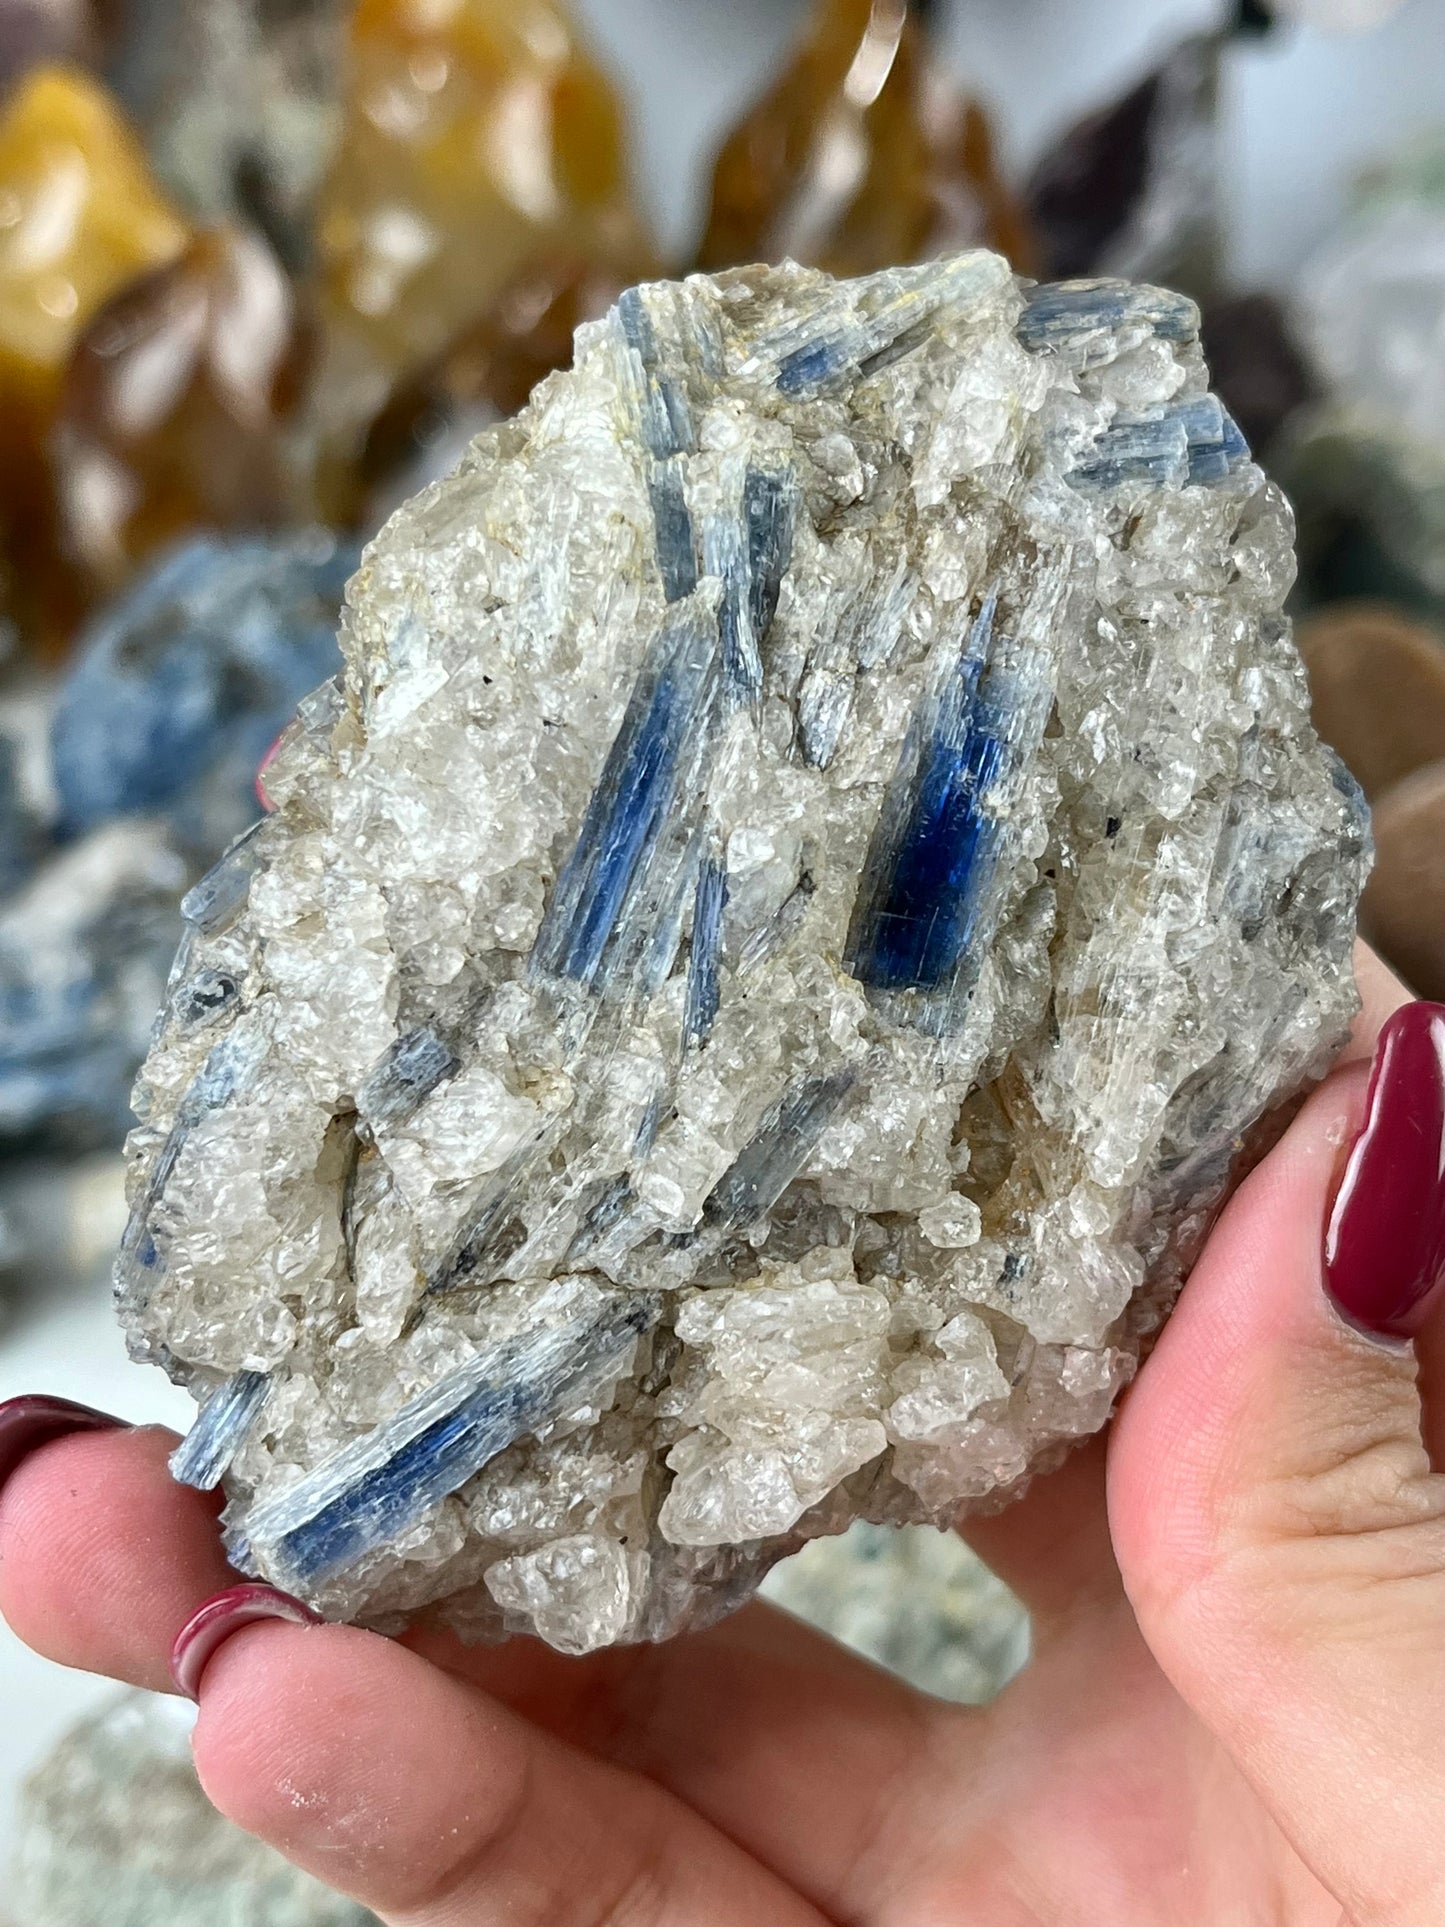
[1110,1004,1445,1927]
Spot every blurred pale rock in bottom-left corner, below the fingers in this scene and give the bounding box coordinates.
[6,1692,376,1927]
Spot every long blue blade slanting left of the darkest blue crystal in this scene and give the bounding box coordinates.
[534,607,717,985]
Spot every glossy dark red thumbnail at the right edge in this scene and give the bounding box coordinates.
[1326,1004,1445,1337]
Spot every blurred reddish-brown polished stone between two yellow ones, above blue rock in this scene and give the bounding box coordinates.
[52,225,306,590]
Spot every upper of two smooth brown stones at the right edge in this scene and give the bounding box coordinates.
[1299,603,1445,800]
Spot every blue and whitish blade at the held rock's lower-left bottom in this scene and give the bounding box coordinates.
[247,1297,657,1588]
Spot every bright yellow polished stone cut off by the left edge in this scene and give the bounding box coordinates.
[0,67,187,649]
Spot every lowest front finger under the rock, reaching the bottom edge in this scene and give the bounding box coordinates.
[195,1624,836,1927]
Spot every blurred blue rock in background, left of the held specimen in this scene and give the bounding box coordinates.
[50,530,356,863]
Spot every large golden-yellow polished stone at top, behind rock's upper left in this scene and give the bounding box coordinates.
[318,0,658,497]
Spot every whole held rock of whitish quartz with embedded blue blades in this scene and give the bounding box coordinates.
[118,252,1366,1651]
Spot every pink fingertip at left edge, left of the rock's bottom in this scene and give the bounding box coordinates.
[0,1428,237,1692]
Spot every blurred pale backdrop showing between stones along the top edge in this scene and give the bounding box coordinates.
[578,0,1445,287]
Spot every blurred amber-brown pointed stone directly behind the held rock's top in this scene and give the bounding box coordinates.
[699,0,1033,274]
